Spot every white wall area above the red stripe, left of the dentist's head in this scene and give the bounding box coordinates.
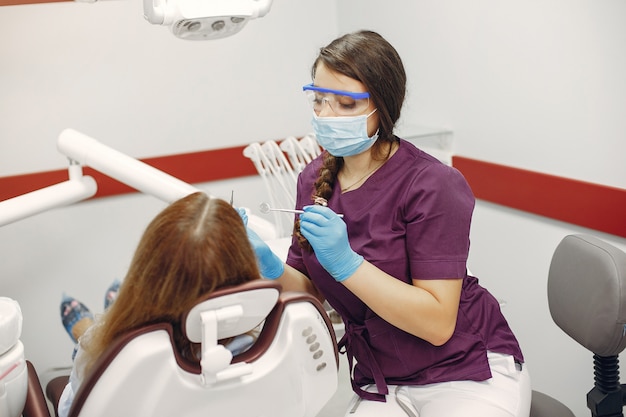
[0,0,336,175]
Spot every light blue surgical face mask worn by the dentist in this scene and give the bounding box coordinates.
[311,109,378,156]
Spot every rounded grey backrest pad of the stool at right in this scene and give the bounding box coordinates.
[548,235,626,356]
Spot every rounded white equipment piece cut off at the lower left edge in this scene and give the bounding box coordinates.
[0,297,28,417]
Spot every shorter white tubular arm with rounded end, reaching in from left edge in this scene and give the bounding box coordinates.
[0,176,98,226]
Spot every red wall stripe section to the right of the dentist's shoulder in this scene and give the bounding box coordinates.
[452,156,626,237]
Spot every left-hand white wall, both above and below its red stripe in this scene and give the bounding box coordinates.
[0,0,337,390]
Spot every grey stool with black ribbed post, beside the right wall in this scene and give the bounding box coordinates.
[530,235,626,417]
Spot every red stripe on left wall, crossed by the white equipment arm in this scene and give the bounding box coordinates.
[0,146,257,201]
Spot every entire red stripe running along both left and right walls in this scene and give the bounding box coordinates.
[0,150,626,237]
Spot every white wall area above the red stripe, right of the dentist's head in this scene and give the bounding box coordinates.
[338,0,626,188]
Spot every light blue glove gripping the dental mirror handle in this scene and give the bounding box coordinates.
[300,205,363,282]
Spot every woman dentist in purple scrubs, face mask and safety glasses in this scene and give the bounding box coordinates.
[243,31,531,417]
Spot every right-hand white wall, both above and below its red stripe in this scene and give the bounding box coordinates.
[338,0,626,417]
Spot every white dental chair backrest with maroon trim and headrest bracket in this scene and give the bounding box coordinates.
[70,280,338,417]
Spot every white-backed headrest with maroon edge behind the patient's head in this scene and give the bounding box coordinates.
[184,279,281,343]
